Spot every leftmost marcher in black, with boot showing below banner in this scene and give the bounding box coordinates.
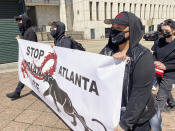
[6,15,37,99]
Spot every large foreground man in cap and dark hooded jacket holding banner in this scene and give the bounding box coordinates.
[100,12,156,131]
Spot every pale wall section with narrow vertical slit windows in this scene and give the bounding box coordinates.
[73,0,175,39]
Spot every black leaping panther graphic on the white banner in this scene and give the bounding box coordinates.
[43,74,107,131]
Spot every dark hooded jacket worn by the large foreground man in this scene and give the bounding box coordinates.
[101,12,156,131]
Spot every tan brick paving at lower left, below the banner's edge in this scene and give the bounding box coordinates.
[0,72,69,131]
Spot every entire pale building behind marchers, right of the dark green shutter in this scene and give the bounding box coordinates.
[26,0,175,39]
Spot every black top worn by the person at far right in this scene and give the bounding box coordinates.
[152,38,175,80]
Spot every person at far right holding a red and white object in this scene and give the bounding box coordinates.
[152,19,175,111]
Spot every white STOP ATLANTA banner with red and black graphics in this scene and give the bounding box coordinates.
[18,39,125,131]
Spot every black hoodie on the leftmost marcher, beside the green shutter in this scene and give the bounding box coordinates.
[20,15,37,42]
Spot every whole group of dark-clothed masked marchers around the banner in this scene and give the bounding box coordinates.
[7,12,175,131]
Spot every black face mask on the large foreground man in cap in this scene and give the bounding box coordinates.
[111,29,129,46]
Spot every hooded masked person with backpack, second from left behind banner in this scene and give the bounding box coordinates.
[49,21,85,51]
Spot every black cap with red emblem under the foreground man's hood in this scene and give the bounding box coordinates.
[104,12,129,25]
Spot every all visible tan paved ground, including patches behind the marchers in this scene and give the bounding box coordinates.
[0,39,175,131]
